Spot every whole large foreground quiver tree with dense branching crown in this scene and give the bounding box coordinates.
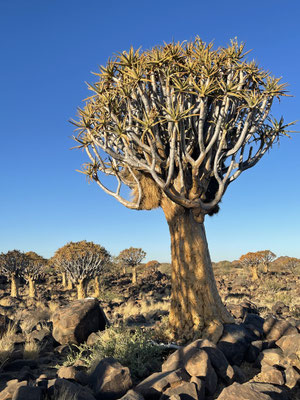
[73,37,290,339]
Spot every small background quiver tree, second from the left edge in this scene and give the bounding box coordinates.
[22,251,47,297]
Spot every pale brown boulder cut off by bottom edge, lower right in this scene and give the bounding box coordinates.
[217,382,288,400]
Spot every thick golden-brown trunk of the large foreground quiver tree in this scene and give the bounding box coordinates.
[162,202,234,342]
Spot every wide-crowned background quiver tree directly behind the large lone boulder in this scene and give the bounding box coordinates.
[53,240,110,299]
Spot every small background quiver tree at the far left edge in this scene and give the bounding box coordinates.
[0,250,29,297]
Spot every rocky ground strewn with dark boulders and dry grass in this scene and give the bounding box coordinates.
[0,266,300,400]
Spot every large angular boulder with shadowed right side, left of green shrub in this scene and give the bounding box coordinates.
[52,298,107,344]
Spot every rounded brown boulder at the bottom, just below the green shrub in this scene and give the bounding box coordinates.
[89,357,132,400]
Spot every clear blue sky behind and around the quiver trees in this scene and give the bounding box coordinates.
[0,0,300,262]
